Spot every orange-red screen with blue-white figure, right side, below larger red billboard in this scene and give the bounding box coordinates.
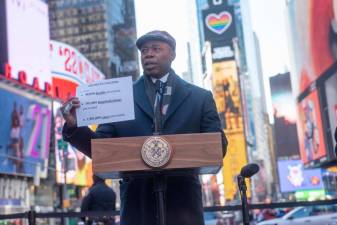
[297,90,327,164]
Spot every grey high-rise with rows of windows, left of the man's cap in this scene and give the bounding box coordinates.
[48,0,139,79]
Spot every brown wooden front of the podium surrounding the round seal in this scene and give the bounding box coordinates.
[91,133,223,179]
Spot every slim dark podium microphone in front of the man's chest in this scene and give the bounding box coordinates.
[153,80,164,134]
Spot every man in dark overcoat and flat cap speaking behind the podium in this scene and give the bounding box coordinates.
[62,30,227,225]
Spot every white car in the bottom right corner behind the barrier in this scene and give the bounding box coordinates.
[257,205,337,225]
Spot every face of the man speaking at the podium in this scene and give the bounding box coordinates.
[140,41,175,78]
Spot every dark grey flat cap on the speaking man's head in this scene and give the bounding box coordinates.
[136,30,176,50]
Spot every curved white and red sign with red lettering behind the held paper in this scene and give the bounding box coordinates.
[49,40,105,100]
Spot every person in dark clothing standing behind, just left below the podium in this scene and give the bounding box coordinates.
[81,175,116,225]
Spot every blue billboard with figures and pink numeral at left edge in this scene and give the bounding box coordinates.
[0,83,51,177]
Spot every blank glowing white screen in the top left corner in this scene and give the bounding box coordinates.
[0,0,51,84]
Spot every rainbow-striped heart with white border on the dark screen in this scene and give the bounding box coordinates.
[205,11,232,34]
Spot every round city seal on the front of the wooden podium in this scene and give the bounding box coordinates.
[141,136,172,168]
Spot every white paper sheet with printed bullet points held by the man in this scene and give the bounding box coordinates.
[76,76,135,127]
